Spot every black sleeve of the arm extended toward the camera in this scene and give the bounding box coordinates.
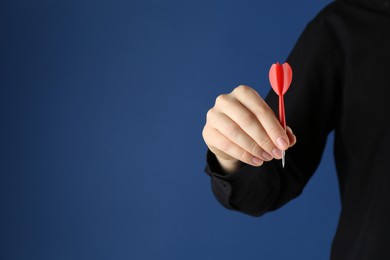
[205,13,341,216]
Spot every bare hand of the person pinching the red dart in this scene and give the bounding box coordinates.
[202,85,296,174]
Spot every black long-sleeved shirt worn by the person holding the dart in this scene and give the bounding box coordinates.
[206,0,390,260]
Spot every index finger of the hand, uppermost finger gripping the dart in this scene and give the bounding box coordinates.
[232,85,290,150]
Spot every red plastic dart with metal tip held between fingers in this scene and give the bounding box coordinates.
[269,62,292,168]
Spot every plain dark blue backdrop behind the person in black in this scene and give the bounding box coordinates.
[0,0,340,260]
